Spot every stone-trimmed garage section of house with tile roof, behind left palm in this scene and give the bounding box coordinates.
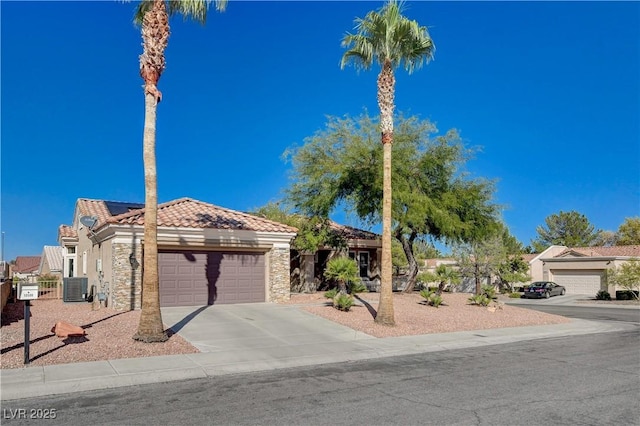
[58,198,297,310]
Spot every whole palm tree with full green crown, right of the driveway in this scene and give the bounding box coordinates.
[340,0,435,325]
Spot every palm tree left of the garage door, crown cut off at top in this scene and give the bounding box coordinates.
[133,0,227,342]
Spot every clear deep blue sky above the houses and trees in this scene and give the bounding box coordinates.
[0,0,640,260]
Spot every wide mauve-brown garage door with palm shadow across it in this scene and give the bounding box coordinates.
[158,251,266,306]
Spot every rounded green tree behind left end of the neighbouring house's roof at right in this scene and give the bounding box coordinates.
[531,211,598,253]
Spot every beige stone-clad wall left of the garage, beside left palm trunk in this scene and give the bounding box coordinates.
[109,243,142,311]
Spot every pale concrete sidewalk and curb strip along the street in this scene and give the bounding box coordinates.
[0,319,635,401]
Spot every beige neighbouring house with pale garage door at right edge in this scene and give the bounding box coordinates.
[540,245,640,296]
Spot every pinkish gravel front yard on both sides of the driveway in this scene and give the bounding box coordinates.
[0,293,570,368]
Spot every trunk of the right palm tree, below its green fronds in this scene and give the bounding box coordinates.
[375,60,396,326]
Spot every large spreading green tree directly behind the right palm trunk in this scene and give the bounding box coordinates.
[285,114,498,291]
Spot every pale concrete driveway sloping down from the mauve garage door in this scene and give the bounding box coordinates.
[162,303,375,357]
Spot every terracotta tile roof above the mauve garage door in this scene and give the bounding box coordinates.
[107,198,297,233]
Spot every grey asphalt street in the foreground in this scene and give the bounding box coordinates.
[2,310,640,425]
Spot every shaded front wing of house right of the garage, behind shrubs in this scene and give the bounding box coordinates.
[291,221,382,292]
